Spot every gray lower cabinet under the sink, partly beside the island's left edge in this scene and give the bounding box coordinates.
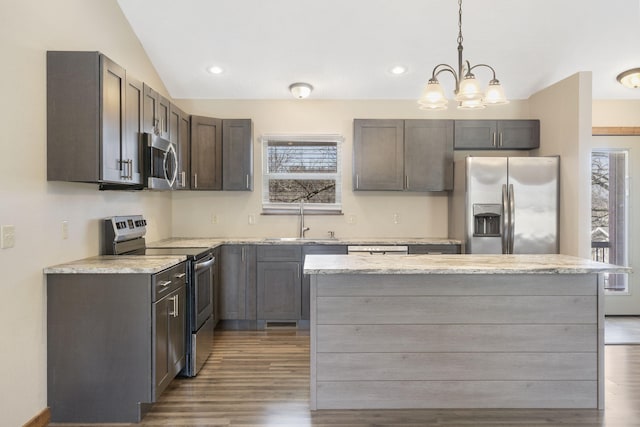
[257,245,302,321]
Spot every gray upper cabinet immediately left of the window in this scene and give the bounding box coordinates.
[222,119,253,191]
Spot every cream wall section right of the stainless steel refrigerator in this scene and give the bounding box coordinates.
[529,72,591,258]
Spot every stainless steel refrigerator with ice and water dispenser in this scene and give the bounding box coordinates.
[449,156,560,254]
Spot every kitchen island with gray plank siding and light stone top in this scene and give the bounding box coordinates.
[304,255,628,410]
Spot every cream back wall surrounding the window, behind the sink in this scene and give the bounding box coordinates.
[173,99,529,241]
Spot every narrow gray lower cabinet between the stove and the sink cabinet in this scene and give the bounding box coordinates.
[218,245,256,320]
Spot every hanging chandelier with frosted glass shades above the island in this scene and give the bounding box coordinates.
[418,0,509,110]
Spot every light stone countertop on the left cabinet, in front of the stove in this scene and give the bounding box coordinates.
[44,255,187,274]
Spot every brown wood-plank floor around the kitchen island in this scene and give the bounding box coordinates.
[51,330,640,427]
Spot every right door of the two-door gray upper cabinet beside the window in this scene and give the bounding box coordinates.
[404,120,453,191]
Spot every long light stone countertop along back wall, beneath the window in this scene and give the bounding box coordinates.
[147,237,462,248]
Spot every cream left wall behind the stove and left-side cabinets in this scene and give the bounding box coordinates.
[0,0,171,426]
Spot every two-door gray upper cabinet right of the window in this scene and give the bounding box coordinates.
[353,119,453,191]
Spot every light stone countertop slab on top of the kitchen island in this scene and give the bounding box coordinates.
[304,254,631,274]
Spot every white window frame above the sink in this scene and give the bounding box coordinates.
[260,134,344,215]
